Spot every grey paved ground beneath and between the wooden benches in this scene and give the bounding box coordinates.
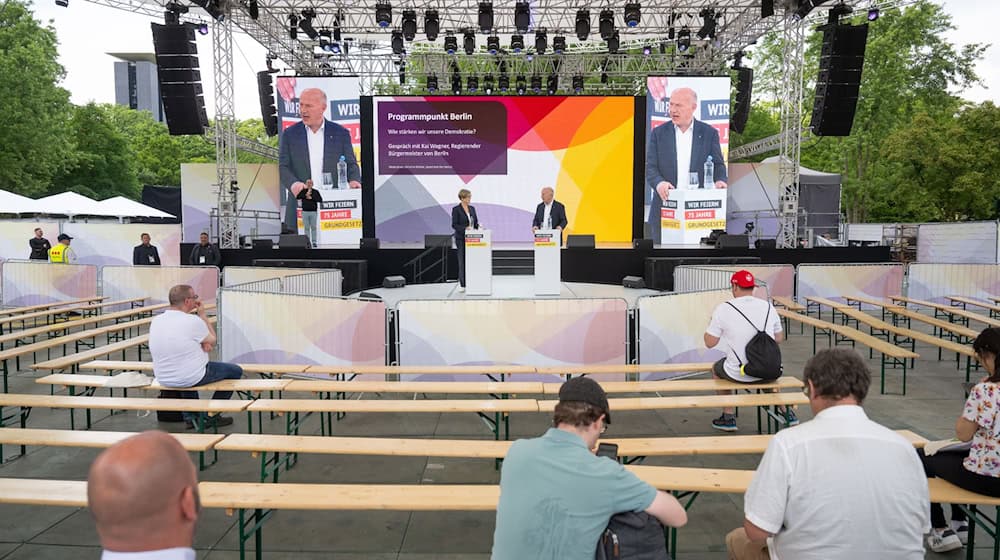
[0,310,992,560]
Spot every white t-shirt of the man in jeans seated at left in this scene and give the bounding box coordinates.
[149,309,209,387]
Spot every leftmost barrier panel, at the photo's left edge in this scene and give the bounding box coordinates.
[2,260,98,307]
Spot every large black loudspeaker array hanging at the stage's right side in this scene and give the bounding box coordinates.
[810,24,868,136]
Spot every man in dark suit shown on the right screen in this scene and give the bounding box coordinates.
[646,88,729,243]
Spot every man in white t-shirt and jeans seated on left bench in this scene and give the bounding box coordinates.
[149,284,243,428]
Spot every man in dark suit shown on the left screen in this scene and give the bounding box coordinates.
[278,88,361,232]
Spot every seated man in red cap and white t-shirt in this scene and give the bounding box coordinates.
[705,270,799,432]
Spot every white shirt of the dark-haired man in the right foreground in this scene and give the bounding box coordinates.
[743,405,931,560]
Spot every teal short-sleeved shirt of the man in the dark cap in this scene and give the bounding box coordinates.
[493,428,656,560]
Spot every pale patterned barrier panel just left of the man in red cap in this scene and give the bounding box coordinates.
[637,288,732,380]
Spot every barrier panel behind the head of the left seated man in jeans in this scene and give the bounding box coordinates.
[101,266,219,304]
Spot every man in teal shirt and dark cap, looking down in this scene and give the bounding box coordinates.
[492,377,687,560]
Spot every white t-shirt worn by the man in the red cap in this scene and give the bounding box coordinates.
[705,296,781,383]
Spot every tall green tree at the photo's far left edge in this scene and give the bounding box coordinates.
[0,0,74,196]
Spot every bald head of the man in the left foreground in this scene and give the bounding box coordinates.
[87,431,201,560]
